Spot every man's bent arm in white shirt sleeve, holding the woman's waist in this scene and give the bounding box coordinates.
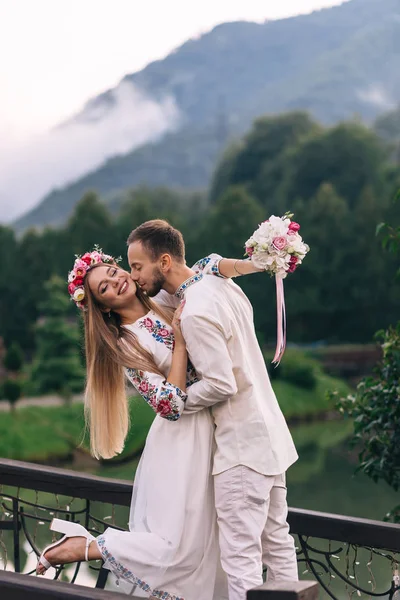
[181,315,237,412]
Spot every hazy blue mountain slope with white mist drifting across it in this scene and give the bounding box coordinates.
[10,0,400,230]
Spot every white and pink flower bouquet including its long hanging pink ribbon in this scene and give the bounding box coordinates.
[245,213,310,366]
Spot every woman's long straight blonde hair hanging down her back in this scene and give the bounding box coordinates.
[83,263,172,458]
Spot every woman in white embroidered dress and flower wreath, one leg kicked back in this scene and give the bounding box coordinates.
[37,249,258,600]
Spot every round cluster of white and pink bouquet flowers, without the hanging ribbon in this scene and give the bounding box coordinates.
[245,213,310,279]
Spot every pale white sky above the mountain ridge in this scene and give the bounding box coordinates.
[0,0,343,221]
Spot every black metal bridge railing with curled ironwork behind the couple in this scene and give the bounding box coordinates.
[0,460,400,600]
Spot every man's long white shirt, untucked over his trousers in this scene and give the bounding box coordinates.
[181,277,297,475]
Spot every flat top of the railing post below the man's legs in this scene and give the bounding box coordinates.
[247,581,318,600]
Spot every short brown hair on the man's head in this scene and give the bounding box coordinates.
[127,219,185,262]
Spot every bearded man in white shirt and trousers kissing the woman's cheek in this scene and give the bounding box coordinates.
[128,220,298,600]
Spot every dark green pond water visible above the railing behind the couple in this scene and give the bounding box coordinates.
[91,421,400,520]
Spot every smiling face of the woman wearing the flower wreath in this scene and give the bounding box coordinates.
[87,265,137,312]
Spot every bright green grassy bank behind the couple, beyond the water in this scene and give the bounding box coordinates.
[0,366,348,464]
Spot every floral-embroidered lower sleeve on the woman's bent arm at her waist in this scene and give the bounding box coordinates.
[126,369,187,421]
